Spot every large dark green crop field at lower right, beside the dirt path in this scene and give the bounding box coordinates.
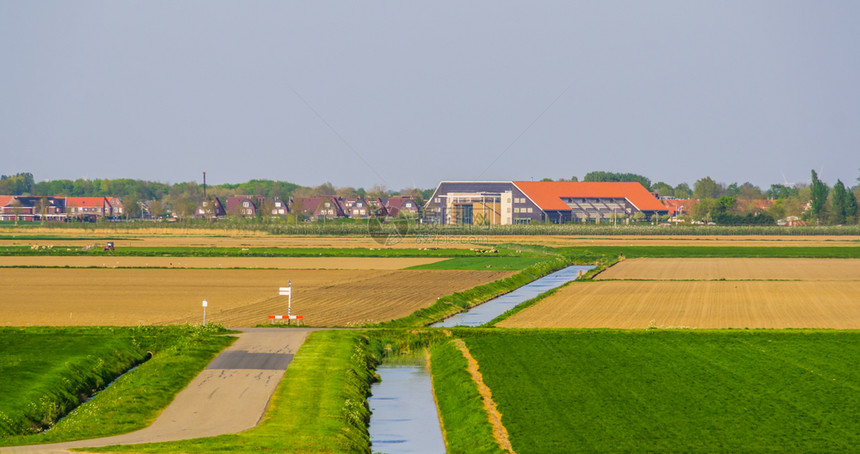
[455,329,860,454]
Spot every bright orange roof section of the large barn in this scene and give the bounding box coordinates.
[513,181,666,211]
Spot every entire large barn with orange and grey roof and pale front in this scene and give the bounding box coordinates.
[424,181,668,225]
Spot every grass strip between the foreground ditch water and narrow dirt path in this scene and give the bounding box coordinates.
[430,342,505,453]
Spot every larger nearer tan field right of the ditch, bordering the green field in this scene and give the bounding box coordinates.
[498,281,860,329]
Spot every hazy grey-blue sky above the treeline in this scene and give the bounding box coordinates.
[0,0,860,189]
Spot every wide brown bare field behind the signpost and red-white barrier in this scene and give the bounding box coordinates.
[0,268,512,327]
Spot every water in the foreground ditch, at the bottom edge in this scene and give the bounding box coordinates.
[367,364,445,454]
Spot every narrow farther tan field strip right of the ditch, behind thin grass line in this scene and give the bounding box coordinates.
[596,258,860,281]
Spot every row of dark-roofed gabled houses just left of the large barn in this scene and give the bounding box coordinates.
[195,195,419,220]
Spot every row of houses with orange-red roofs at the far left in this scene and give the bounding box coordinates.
[0,195,125,221]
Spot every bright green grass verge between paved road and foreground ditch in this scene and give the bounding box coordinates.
[87,330,376,453]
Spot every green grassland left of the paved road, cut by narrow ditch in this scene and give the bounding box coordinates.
[0,325,235,446]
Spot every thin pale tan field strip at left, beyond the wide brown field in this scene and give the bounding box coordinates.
[0,256,445,270]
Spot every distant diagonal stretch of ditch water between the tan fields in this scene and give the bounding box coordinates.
[432,265,594,327]
